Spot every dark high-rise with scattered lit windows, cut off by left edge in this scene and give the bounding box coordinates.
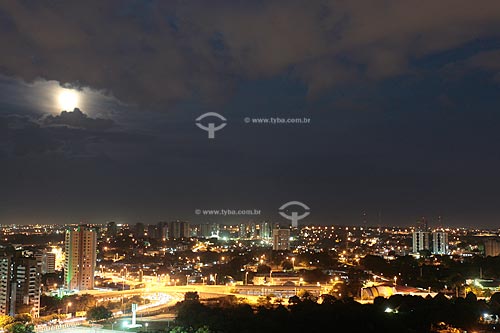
[0,252,41,317]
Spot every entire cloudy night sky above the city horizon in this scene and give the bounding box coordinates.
[0,0,500,227]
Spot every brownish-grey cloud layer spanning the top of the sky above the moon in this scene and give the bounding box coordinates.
[0,0,500,107]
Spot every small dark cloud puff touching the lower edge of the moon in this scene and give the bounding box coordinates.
[43,108,113,131]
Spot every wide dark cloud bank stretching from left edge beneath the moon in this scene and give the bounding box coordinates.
[0,109,153,157]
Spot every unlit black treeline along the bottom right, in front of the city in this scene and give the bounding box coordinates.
[171,293,500,333]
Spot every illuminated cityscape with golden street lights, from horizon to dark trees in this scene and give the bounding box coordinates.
[0,220,500,330]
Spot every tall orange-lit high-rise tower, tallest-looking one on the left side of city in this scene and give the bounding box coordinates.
[64,226,97,290]
